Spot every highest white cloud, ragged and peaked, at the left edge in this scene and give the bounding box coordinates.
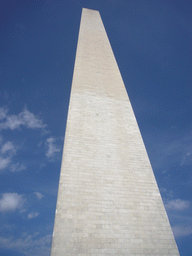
[0,108,46,130]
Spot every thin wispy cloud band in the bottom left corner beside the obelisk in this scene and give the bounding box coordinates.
[0,233,52,256]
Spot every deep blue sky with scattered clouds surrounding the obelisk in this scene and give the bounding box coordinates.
[0,0,192,256]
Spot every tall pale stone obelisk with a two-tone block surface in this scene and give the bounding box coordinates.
[51,9,179,256]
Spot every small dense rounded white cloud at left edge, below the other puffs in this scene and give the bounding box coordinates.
[0,193,25,212]
